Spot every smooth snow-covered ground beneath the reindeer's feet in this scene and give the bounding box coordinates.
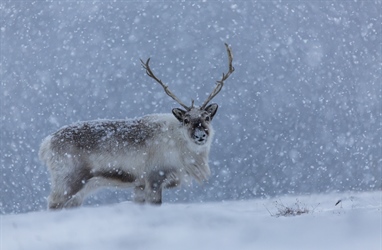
[1,192,382,250]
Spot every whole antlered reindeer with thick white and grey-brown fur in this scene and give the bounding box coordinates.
[39,44,235,209]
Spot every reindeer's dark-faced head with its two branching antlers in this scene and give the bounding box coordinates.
[141,44,235,145]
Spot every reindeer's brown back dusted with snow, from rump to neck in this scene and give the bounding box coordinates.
[39,114,177,163]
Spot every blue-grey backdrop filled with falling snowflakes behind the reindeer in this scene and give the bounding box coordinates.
[0,0,382,213]
